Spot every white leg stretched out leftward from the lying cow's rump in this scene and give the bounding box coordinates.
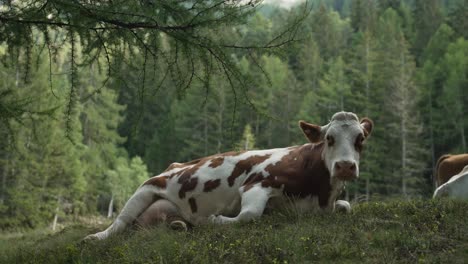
[85,186,156,240]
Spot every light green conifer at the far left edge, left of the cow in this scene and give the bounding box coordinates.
[0,50,87,228]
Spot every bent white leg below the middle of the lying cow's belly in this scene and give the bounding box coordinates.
[209,183,272,224]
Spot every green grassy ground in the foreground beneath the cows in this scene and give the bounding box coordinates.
[0,200,468,263]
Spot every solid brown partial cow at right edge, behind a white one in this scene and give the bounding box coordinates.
[433,154,468,187]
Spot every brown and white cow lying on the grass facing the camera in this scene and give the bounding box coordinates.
[87,112,373,239]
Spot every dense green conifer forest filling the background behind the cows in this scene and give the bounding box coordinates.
[0,0,468,229]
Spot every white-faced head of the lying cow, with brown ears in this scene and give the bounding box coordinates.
[299,112,373,180]
